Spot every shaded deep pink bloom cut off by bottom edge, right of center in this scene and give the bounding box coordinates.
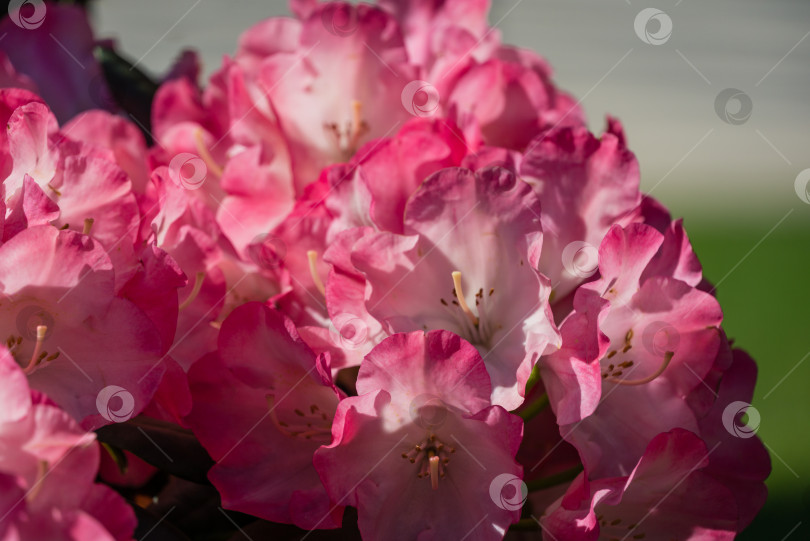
[543,429,737,541]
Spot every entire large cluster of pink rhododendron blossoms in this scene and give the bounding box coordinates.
[0,0,770,540]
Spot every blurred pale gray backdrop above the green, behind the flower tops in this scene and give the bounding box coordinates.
[94,0,810,219]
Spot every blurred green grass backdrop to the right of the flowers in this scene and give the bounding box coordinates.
[681,205,810,540]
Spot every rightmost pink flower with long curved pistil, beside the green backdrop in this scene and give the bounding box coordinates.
[541,224,722,477]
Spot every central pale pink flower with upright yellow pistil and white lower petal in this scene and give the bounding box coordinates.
[327,168,559,409]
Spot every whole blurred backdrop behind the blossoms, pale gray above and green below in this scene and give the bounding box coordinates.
[85,0,810,541]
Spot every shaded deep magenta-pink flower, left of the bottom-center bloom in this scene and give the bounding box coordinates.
[186,303,343,528]
